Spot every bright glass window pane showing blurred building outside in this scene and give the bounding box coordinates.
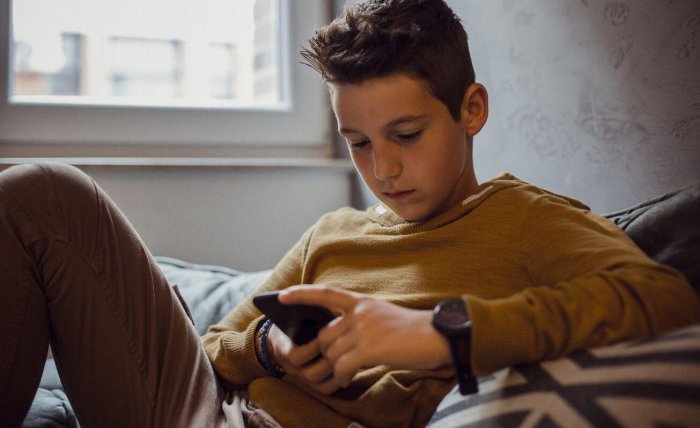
[12,0,283,107]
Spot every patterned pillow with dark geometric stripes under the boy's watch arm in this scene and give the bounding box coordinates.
[429,325,700,428]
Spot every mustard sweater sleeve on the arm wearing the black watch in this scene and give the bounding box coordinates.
[467,194,700,375]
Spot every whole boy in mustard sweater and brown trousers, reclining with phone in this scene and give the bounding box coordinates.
[0,0,700,427]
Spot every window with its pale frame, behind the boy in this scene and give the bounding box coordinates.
[0,0,332,155]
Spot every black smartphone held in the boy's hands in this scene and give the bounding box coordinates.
[253,291,335,345]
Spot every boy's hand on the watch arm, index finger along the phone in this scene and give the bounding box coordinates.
[279,285,451,389]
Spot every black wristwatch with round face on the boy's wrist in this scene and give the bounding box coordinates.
[433,298,479,395]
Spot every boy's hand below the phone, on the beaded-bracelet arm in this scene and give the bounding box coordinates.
[267,324,338,394]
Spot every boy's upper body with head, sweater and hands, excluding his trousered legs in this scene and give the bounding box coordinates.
[203,0,700,426]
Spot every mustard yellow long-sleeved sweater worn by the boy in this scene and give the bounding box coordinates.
[202,175,700,427]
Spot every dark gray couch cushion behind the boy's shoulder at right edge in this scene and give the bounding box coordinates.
[606,183,700,293]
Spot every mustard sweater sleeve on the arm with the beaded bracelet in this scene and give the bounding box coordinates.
[202,228,313,388]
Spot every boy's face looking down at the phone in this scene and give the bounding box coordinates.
[330,74,477,221]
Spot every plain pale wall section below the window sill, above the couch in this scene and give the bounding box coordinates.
[83,167,350,271]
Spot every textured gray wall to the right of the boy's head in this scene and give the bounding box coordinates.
[448,0,700,212]
